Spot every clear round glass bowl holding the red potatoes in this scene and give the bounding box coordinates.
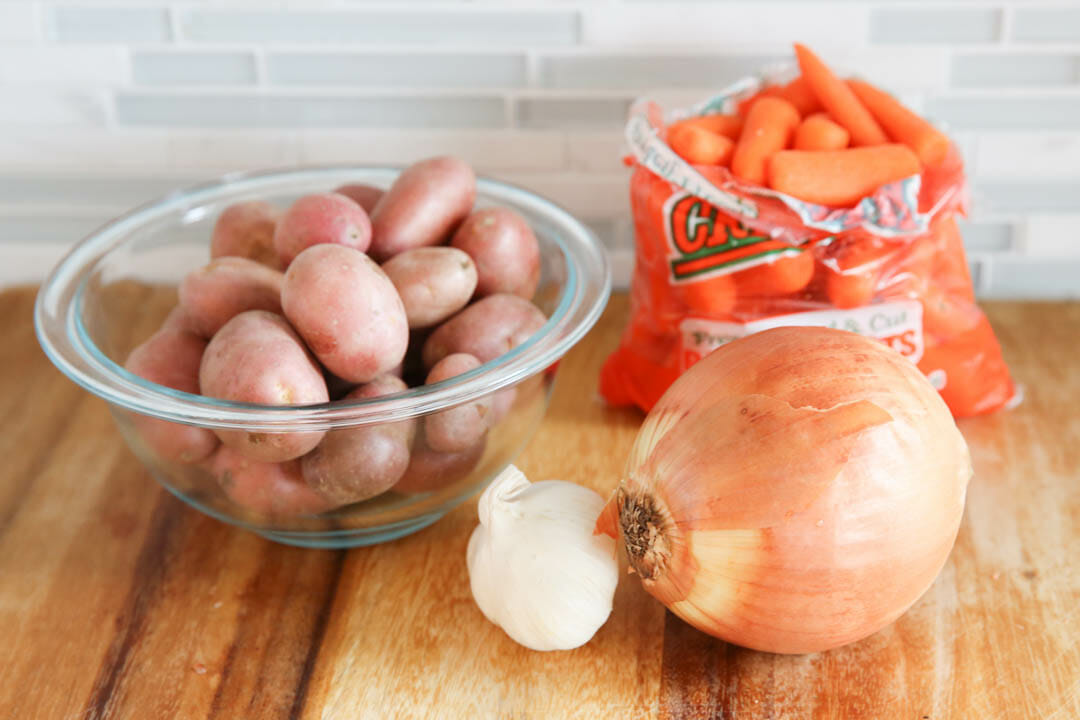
[35,167,611,547]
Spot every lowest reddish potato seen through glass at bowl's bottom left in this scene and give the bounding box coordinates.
[210,447,334,518]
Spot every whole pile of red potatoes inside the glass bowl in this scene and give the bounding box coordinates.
[125,157,546,517]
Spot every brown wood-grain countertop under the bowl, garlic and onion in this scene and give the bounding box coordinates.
[0,289,1080,720]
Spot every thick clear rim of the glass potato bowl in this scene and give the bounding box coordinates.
[33,164,611,432]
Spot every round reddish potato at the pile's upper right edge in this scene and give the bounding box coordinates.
[450,207,540,300]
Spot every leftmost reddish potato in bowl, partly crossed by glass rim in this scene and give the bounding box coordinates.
[124,327,218,464]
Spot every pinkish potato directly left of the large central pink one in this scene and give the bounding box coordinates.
[179,257,285,338]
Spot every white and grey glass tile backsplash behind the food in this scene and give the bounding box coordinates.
[0,0,1080,297]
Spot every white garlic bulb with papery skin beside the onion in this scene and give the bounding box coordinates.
[468,465,619,650]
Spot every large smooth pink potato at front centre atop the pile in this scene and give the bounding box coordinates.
[281,245,408,382]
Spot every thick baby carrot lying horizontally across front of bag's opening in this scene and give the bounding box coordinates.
[768,145,919,207]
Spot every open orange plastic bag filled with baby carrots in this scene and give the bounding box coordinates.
[600,46,1015,417]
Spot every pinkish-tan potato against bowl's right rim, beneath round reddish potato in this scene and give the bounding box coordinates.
[423,293,548,368]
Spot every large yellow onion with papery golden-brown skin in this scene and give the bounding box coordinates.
[596,327,971,653]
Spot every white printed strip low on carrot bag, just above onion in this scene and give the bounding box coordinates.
[679,300,924,370]
